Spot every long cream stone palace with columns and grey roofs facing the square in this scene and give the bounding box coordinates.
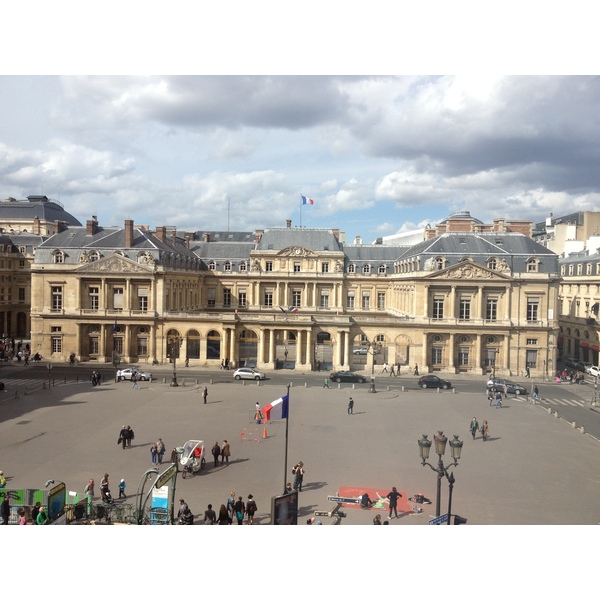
[31,213,559,375]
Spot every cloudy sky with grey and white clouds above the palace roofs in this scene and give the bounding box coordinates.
[0,5,600,241]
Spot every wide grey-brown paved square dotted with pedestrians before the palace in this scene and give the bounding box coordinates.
[0,375,600,526]
